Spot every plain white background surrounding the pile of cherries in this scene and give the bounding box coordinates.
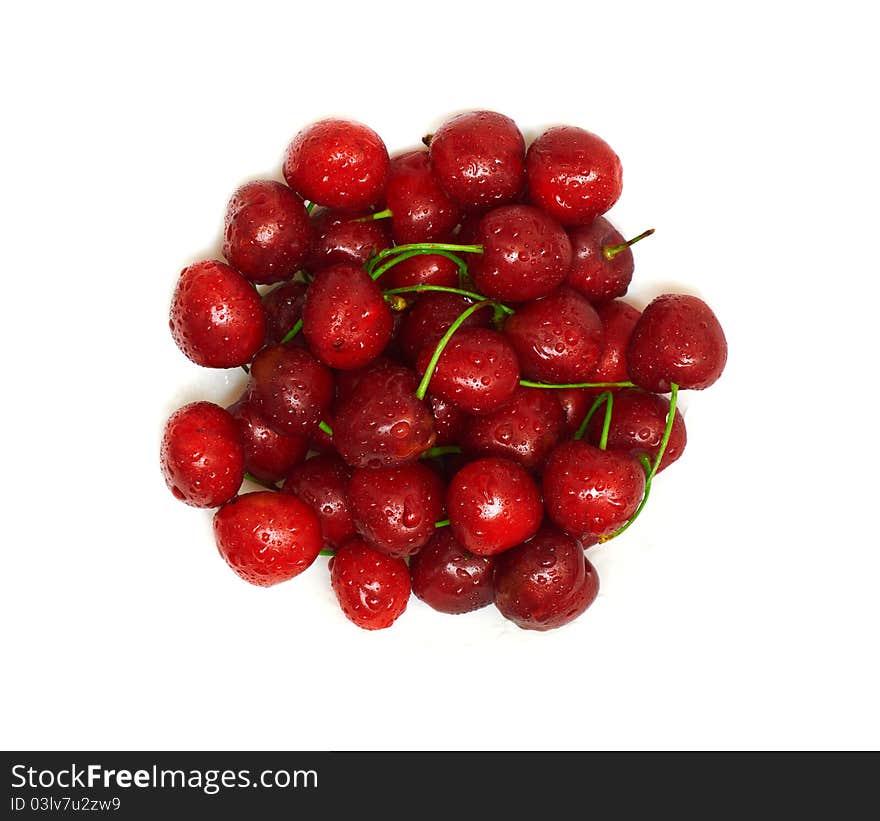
[0,0,880,749]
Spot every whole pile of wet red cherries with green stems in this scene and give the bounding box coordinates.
[161,111,727,630]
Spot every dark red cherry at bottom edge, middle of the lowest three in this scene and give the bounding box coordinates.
[409,527,495,615]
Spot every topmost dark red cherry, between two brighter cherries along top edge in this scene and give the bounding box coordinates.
[430,111,525,208]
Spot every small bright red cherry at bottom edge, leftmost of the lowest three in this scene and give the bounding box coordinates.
[330,538,410,630]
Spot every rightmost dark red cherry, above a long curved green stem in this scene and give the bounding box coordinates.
[627,294,727,393]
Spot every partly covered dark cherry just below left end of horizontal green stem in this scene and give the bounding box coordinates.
[460,387,565,470]
